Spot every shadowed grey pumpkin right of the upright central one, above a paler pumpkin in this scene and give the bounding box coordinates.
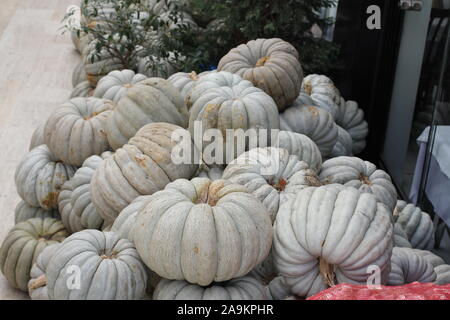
[280,105,338,157]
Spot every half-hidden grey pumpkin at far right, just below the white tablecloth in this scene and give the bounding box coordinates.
[395,200,434,250]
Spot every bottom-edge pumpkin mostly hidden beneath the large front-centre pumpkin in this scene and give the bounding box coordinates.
[153,276,270,300]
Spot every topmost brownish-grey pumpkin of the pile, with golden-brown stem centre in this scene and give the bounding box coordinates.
[218,38,303,111]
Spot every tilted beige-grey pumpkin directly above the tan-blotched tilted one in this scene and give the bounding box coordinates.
[106,78,189,149]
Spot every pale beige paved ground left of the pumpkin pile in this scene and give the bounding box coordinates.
[0,0,80,300]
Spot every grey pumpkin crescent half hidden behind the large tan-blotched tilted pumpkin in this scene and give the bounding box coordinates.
[58,153,111,233]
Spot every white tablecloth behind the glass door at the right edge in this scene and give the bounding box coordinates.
[409,126,450,226]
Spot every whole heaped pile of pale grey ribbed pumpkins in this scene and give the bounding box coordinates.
[0,18,450,300]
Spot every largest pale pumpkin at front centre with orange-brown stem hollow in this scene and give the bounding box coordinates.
[133,178,272,286]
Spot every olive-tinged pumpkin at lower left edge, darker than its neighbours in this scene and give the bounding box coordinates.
[0,218,68,292]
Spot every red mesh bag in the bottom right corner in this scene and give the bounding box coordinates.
[307,282,450,300]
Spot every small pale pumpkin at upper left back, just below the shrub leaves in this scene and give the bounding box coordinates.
[94,69,147,103]
